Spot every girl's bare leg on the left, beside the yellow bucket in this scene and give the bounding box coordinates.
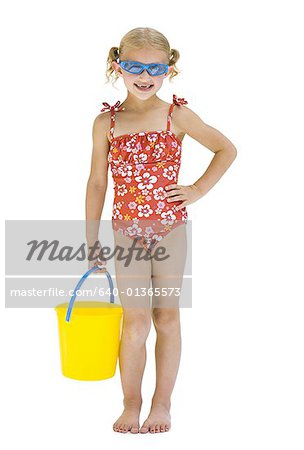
[113,231,151,433]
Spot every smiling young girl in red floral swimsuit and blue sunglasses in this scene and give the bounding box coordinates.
[86,28,237,433]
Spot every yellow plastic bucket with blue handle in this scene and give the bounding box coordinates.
[55,266,123,381]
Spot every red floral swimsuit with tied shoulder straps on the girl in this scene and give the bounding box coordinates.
[101,94,188,252]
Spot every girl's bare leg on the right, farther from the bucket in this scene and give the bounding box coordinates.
[140,224,187,433]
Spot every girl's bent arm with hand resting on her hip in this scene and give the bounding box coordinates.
[167,106,237,209]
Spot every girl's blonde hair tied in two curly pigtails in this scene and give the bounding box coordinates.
[106,27,180,85]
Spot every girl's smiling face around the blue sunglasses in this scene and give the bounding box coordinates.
[112,48,173,100]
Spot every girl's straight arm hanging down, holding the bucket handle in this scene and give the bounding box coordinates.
[85,112,110,266]
